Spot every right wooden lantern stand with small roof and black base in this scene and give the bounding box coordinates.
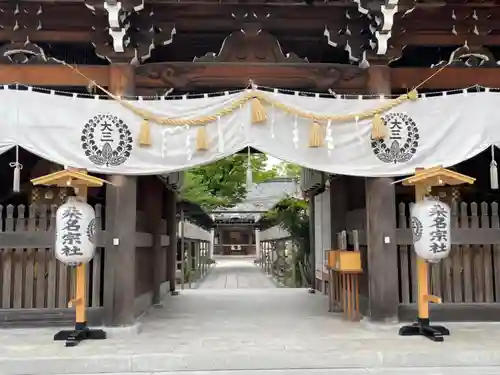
[398,166,476,342]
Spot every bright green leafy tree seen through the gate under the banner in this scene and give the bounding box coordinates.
[181,154,277,210]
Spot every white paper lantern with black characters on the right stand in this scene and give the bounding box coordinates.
[411,199,451,263]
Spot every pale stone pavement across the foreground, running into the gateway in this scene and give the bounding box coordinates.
[0,260,500,375]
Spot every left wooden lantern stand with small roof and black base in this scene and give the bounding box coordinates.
[31,168,107,346]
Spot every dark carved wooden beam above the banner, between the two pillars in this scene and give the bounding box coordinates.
[136,62,366,92]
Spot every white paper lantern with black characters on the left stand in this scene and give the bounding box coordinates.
[54,197,95,266]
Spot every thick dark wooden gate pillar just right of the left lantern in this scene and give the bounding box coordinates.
[103,64,137,326]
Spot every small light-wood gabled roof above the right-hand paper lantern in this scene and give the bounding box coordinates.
[398,166,476,186]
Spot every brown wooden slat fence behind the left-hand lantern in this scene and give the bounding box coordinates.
[0,205,104,309]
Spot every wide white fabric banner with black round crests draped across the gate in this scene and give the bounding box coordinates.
[0,90,500,177]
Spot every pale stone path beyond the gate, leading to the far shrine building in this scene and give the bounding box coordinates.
[199,256,276,289]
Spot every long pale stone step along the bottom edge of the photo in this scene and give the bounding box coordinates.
[0,350,500,375]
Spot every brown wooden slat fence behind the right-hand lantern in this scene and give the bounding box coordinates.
[397,202,500,304]
